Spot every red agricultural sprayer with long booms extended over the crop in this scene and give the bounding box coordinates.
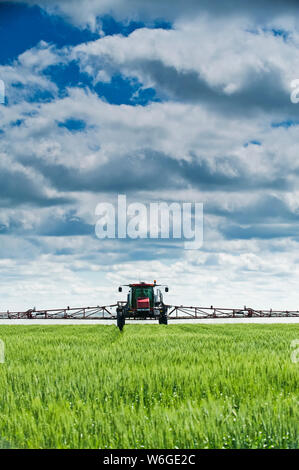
[0,281,299,330]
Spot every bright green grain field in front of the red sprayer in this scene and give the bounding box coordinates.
[0,325,299,448]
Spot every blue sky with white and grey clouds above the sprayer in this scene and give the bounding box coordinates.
[0,0,299,310]
